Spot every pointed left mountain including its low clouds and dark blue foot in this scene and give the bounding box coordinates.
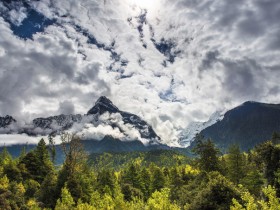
[0,96,164,154]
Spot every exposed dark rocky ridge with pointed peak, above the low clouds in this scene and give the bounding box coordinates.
[0,96,160,145]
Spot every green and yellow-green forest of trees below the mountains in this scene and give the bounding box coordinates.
[0,133,280,210]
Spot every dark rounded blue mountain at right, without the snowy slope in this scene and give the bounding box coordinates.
[194,101,280,151]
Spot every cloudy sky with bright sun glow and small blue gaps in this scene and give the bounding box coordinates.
[0,0,280,142]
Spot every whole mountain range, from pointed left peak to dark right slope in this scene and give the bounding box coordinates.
[0,96,280,153]
